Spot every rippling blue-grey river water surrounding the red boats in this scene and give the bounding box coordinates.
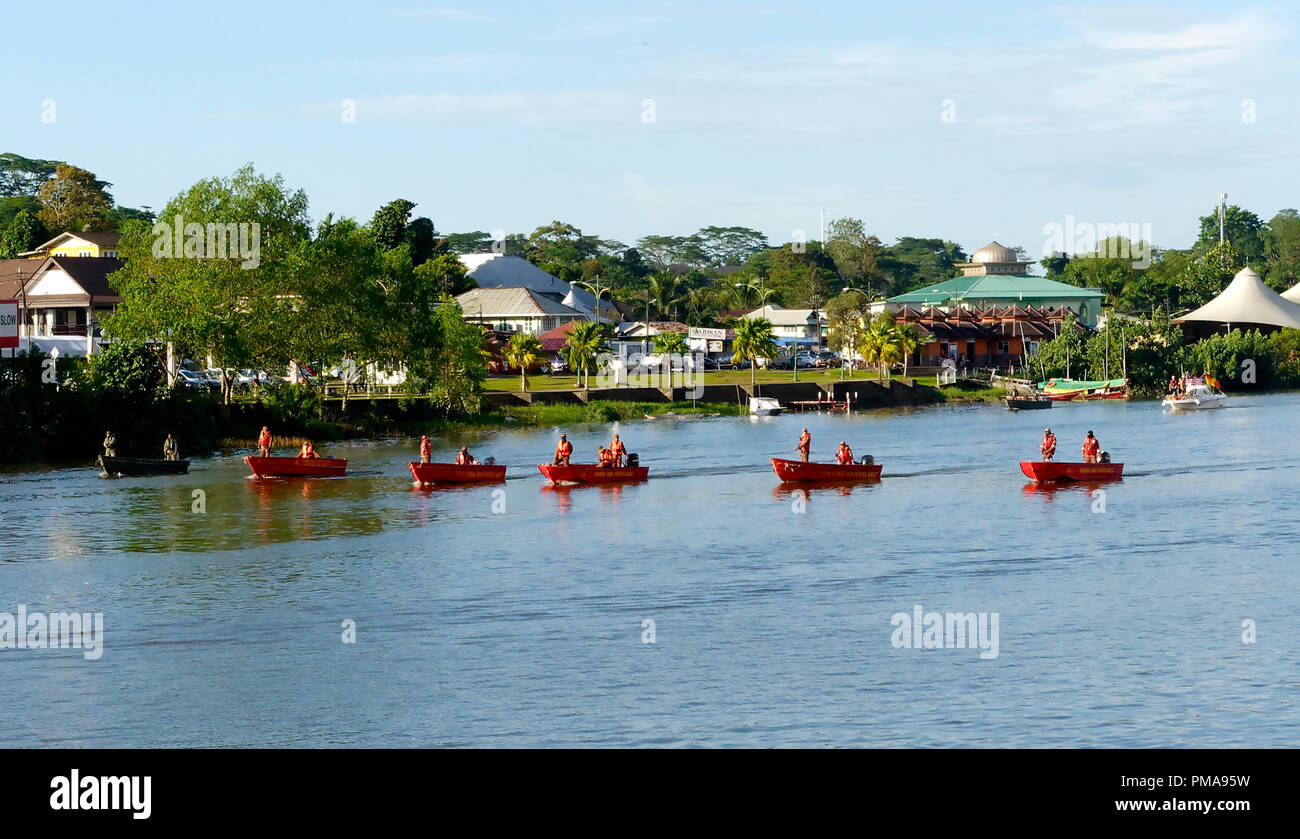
[0,394,1300,747]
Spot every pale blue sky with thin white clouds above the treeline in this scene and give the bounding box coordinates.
[0,0,1300,256]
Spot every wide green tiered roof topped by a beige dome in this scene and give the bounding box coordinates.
[888,242,1106,326]
